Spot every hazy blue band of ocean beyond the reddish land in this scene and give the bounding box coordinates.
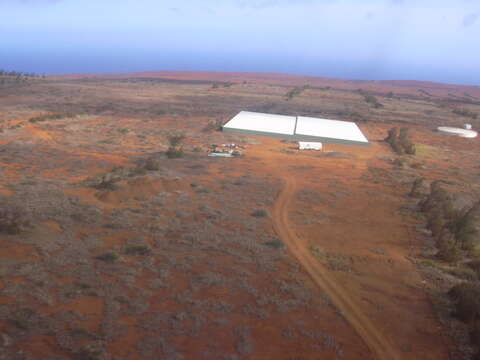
[0,49,480,86]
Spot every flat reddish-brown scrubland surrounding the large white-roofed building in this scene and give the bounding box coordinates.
[0,72,480,360]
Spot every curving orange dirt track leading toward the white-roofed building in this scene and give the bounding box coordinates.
[273,177,401,360]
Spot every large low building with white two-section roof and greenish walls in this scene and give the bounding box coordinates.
[223,111,370,146]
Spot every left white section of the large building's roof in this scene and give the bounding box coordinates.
[224,111,295,135]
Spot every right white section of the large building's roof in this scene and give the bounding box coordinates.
[295,116,368,143]
